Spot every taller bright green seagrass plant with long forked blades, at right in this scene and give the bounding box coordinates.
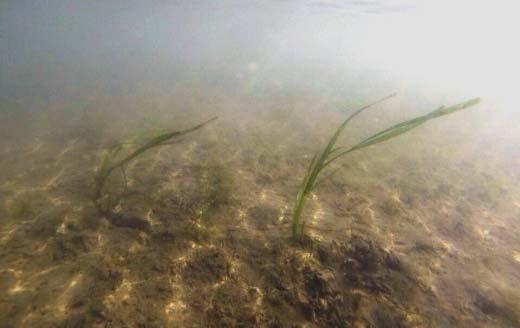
[292,94,480,241]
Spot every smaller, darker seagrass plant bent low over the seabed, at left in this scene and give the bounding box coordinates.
[94,117,217,210]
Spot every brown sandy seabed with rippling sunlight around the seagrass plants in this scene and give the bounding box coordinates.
[0,89,520,327]
